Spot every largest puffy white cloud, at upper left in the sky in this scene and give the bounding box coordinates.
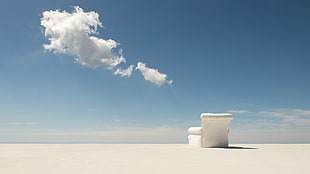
[41,6,126,68]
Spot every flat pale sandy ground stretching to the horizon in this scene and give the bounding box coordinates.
[0,144,310,174]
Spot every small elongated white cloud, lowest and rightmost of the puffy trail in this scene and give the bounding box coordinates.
[136,62,173,85]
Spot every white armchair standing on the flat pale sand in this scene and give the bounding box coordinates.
[188,113,233,147]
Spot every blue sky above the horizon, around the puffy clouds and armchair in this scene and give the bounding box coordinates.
[0,0,310,143]
